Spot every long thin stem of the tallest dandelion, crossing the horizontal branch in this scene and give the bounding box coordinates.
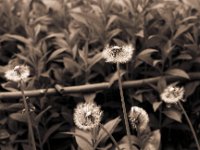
[117,63,132,150]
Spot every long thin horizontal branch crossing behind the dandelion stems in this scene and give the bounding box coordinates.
[0,72,200,99]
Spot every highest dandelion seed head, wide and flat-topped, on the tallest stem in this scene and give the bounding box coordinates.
[102,44,134,63]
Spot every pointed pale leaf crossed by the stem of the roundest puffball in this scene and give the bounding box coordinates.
[97,117,121,143]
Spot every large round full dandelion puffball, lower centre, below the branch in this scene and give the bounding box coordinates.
[74,103,103,130]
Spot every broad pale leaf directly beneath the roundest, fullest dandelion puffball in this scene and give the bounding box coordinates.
[74,128,93,150]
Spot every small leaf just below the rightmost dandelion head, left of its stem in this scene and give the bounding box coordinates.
[163,109,182,122]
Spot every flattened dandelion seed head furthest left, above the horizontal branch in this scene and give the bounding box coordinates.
[5,65,30,82]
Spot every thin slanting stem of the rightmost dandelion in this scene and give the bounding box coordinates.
[178,102,200,150]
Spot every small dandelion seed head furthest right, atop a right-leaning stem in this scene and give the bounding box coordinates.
[160,84,185,104]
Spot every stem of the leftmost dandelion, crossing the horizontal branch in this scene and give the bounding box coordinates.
[20,80,36,150]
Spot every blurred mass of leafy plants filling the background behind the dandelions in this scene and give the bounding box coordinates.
[0,0,200,150]
